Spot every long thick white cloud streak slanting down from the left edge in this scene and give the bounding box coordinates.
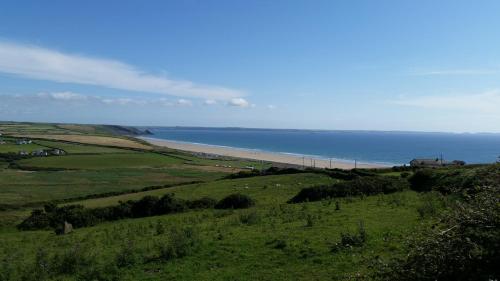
[0,42,244,100]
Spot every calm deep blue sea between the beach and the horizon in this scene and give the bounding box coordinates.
[150,127,500,164]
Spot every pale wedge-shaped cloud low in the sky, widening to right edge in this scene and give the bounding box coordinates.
[390,90,500,112]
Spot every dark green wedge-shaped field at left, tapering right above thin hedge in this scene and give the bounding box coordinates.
[0,169,217,206]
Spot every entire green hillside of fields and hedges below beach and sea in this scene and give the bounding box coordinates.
[0,123,500,280]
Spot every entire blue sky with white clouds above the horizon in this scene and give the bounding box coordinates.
[0,0,500,132]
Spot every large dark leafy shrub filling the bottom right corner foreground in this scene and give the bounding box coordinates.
[381,186,500,280]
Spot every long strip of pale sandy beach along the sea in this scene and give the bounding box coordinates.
[140,137,387,169]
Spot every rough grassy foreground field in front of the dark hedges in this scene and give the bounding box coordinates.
[0,182,425,280]
